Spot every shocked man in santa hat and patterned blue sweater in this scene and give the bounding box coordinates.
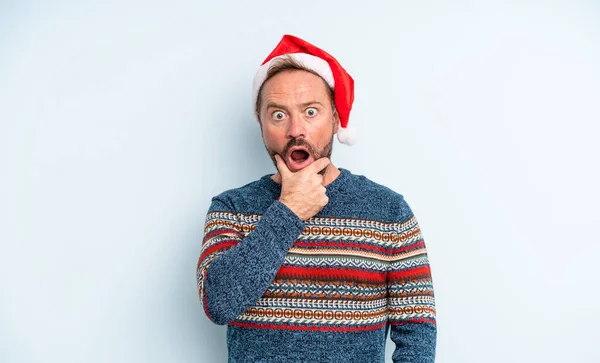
[197,35,436,363]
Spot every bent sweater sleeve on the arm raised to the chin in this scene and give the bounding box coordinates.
[196,197,304,325]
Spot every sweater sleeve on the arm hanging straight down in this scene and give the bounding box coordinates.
[387,199,437,363]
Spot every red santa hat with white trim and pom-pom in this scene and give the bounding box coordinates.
[252,34,356,145]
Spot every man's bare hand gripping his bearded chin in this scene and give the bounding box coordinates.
[275,154,330,221]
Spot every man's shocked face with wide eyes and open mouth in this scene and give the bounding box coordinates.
[259,70,339,172]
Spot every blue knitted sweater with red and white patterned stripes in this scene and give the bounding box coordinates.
[197,169,436,363]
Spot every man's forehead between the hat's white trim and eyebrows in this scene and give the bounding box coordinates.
[261,70,329,104]
